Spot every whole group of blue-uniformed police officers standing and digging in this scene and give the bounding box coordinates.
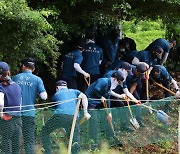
[0,26,180,154]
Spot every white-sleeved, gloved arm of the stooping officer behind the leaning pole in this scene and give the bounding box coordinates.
[78,93,91,119]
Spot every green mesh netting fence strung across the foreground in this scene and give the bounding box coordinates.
[0,97,180,153]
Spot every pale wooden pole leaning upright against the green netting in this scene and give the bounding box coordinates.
[68,99,81,154]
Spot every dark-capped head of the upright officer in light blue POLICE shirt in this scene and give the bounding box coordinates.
[22,58,35,72]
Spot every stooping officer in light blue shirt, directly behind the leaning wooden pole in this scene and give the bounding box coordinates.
[42,80,91,154]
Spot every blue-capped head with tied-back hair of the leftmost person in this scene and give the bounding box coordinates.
[0,62,10,85]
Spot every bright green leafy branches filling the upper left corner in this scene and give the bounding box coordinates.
[0,0,61,76]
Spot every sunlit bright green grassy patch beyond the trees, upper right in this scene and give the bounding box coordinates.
[122,20,165,50]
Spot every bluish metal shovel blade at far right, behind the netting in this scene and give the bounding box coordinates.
[157,110,171,126]
